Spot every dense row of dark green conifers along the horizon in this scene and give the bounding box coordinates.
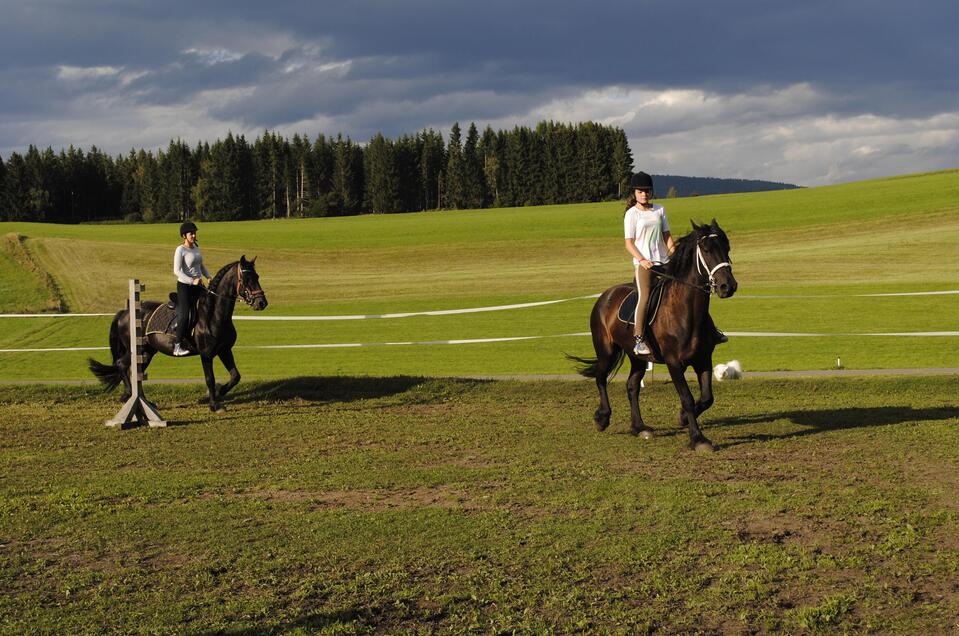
[0,122,633,223]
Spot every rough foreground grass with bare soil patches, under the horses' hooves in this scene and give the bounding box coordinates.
[0,376,959,634]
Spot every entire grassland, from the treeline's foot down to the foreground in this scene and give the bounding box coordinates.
[0,170,959,634]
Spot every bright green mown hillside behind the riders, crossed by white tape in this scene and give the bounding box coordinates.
[0,170,959,379]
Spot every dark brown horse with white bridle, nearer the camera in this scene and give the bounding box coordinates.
[569,219,737,451]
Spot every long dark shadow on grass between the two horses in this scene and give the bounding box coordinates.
[224,376,491,406]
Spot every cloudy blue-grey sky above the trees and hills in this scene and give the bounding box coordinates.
[0,0,959,186]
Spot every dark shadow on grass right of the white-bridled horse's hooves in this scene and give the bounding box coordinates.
[704,406,959,447]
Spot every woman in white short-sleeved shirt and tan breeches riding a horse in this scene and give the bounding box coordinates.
[623,172,676,355]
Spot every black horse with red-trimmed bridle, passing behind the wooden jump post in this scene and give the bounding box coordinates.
[87,256,267,412]
